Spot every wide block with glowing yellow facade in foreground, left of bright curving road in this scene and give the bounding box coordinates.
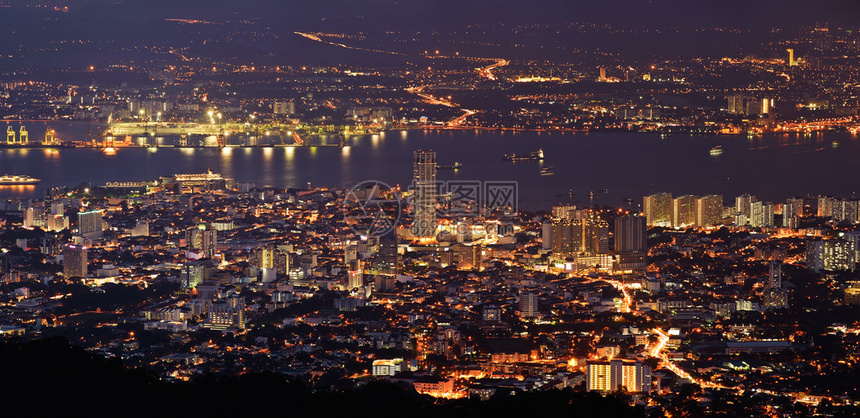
[586,359,651,393]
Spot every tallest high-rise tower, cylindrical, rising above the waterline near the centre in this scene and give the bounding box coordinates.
[412,150,436,238]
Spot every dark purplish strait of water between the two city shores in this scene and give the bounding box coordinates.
[0,124,860,209]
